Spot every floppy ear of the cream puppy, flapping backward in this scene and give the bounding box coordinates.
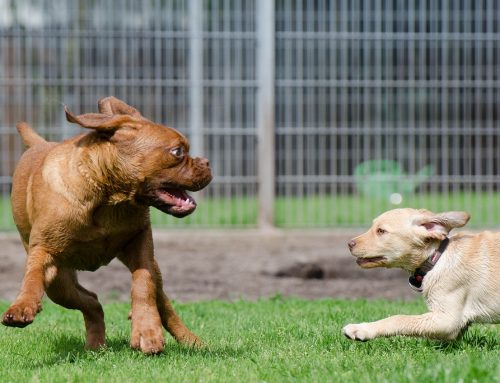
[414,211,470,241]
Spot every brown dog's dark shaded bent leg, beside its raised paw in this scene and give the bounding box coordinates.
[47,269,106,350]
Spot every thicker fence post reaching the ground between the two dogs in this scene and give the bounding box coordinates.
[256,0,275,229]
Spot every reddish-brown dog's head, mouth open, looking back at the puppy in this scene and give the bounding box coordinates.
[65,97,212,217]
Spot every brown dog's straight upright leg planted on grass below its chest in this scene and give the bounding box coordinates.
[119,228,164,354]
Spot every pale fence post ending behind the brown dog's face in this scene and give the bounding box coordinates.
[188,0,204,156]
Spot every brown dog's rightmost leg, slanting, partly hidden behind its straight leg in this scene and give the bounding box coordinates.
[154,259,203,347]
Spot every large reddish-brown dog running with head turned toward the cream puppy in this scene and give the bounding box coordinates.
[2,97,212,354]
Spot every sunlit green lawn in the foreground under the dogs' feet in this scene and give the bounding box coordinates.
[0,296,500,383]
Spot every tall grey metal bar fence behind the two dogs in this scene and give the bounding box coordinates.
[0,0,500,229]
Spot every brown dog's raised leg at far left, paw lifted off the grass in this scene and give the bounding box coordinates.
[2,248,52,327]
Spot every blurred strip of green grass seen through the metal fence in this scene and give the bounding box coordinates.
[0,192,500,231]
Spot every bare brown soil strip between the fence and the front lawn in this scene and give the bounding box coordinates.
[0,230,418,302]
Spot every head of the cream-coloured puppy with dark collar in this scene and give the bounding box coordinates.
[348,209,470,272]
